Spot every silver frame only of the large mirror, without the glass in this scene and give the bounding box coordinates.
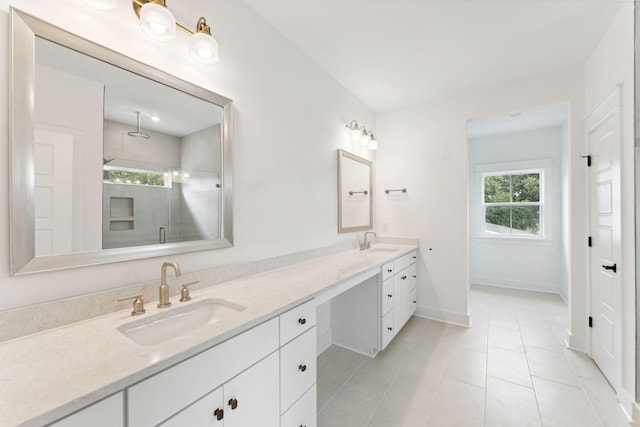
[9,8,233,275]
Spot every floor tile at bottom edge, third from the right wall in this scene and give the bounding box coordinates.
[485,377,542,427]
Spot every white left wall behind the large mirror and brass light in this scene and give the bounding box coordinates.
[0,0,377,309]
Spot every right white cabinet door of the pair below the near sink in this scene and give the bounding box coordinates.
[225,352,280,427]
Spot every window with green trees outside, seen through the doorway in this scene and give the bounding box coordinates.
[482,170,543,237]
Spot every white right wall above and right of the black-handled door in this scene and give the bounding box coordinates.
[584,2,636,413]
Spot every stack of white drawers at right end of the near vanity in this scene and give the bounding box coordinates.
[280,300,317,427]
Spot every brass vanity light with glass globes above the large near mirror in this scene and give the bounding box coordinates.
[84,0,219,64]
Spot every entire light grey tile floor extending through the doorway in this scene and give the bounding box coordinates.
[318,285,629,427]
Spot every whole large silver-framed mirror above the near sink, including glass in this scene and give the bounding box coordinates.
[10,9,233,275]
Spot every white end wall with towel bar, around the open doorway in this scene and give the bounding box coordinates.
[376,68,586,323]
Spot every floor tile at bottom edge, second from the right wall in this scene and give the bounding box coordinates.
[533,377,600,427]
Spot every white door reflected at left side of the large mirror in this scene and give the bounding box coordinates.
[34,129,73,256]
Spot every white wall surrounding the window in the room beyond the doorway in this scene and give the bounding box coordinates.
[469,126,568,299]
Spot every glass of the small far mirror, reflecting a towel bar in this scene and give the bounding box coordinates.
[338,150,373,233]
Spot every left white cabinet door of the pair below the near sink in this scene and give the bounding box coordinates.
[159,387,224,427]
